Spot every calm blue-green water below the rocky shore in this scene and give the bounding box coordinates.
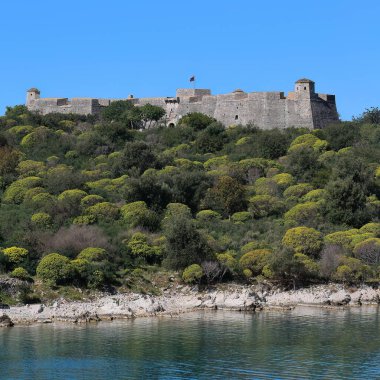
[0,307,380,380]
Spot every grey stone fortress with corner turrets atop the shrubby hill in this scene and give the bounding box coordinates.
[26,79,339,129]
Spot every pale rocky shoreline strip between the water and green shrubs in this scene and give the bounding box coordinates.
[0,284,380,327]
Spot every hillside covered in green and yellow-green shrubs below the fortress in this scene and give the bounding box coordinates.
[0,102,380,300]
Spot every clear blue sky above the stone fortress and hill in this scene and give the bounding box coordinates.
[0,0,380,119]
